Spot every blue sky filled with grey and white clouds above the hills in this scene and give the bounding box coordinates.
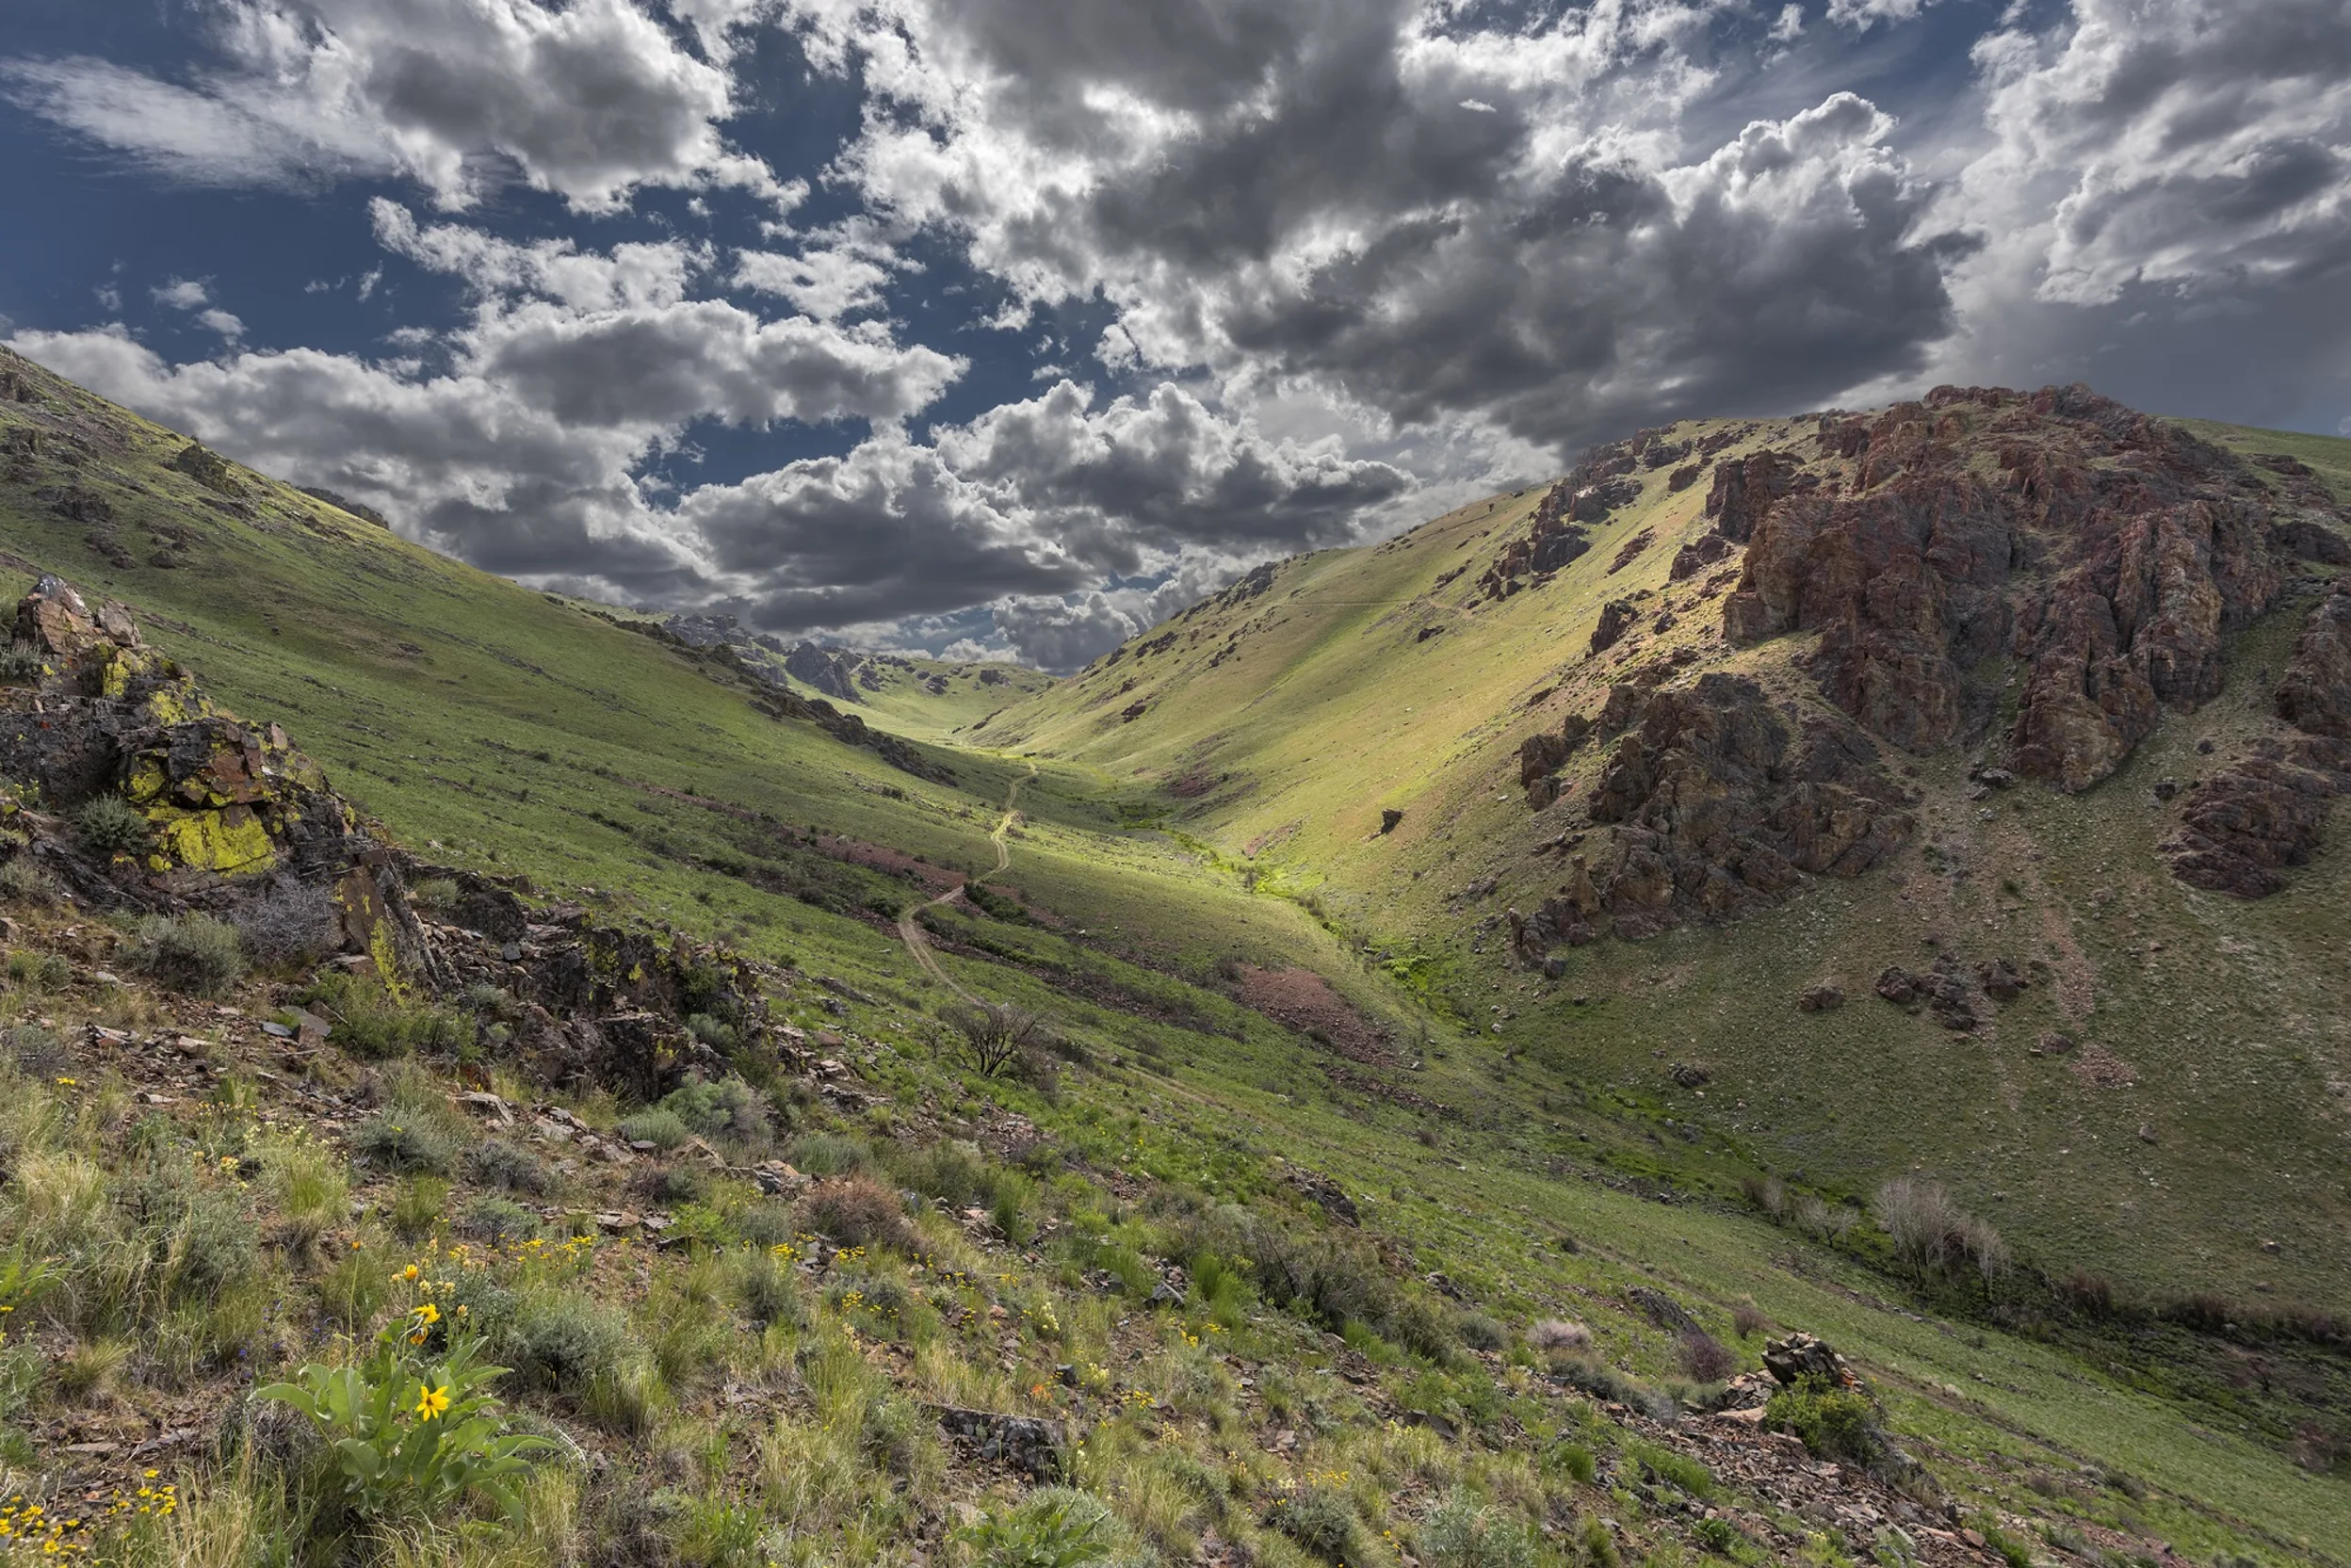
[0,0,2351,670]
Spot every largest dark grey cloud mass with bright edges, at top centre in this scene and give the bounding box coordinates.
[809,0,1970,451]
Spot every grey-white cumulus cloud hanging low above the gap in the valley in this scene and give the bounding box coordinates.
[677,383,1411,668]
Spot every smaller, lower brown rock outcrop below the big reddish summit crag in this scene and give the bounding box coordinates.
[1514,674,1911,954]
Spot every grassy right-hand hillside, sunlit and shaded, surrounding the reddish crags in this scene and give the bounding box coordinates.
[978,409,2351,1302]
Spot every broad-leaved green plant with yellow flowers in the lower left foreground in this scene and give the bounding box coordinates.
[254,1302,555,1524]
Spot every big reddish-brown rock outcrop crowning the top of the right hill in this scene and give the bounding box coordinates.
[1710,385,2304,790]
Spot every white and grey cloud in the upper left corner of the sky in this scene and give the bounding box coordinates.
[0,0,800,212]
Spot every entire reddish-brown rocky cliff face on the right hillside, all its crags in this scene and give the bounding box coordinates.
[1504,385,2351,962]
